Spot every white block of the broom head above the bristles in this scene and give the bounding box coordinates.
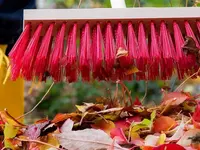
[24,7,200,21]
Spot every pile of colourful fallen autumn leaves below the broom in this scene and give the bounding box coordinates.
[0,89,200,150]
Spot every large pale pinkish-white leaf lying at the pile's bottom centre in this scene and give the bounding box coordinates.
[57,129,128,150]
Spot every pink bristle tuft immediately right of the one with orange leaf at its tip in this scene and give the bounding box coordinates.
[136,22,149,80]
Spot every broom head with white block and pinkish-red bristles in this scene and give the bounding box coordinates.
[9,7,200,82]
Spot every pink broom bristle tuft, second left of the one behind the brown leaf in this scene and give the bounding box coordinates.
[160,21,174,80]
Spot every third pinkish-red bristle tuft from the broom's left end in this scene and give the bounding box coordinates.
[33,23,54,81]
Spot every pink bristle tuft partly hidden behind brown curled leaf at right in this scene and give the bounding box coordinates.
[184,21,200,75]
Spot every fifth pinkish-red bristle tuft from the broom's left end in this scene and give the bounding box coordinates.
[62,23,77,83]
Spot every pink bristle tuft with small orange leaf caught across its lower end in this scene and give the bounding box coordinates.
[127,22,138,80]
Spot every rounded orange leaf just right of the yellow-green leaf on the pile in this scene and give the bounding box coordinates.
[152,116,177,133]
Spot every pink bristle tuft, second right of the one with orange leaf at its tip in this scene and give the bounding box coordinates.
[148,21,161,80]
